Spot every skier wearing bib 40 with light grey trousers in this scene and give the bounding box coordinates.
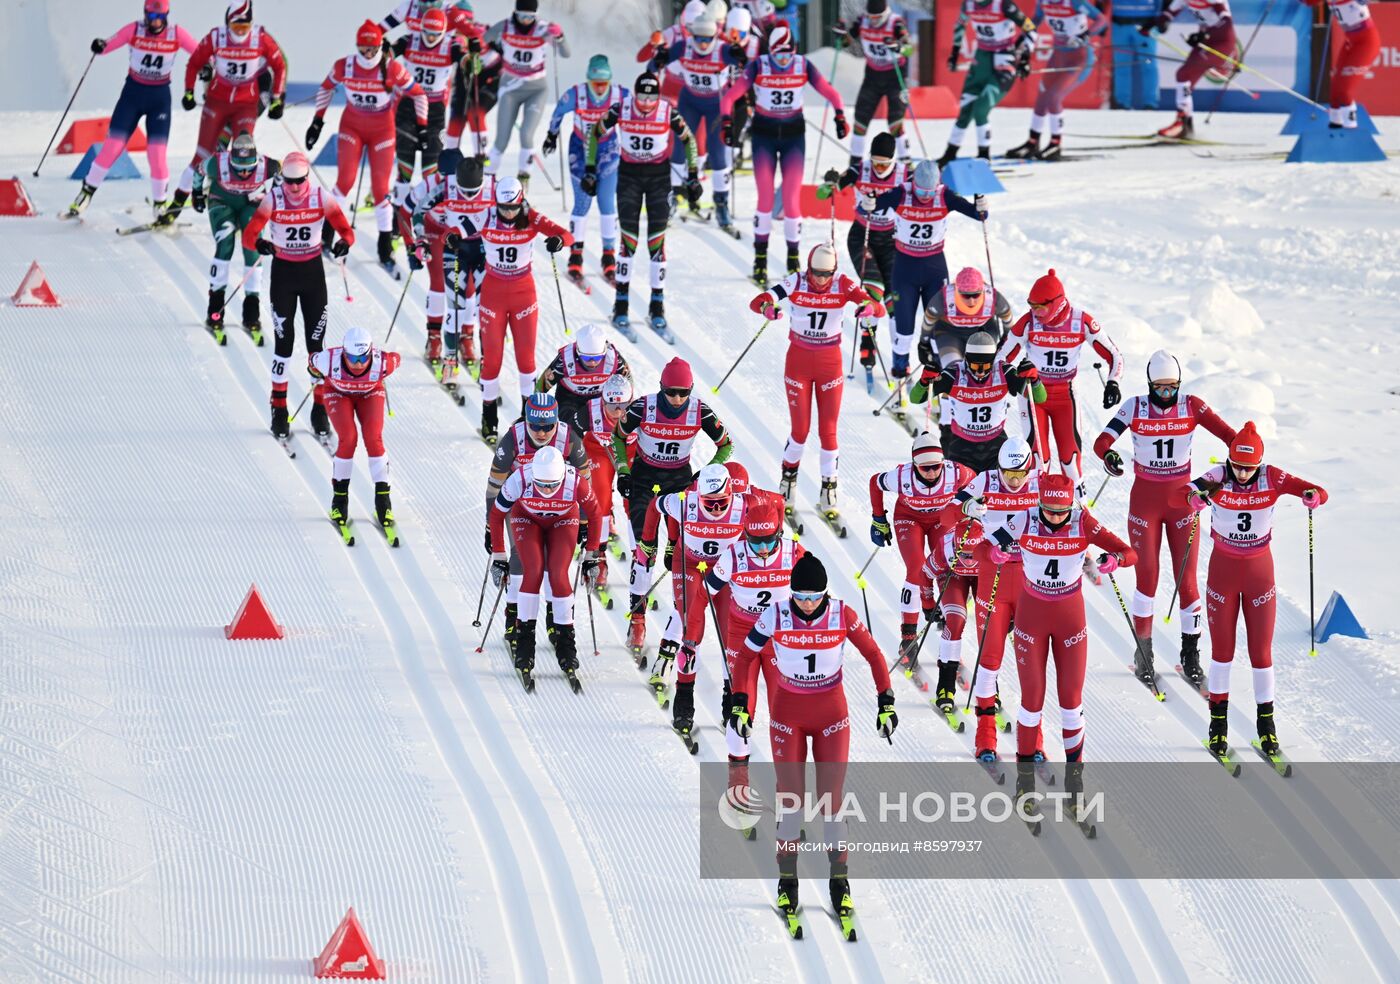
[486,0,568,183]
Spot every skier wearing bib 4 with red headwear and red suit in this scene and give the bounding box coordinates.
[990,475,1137,798]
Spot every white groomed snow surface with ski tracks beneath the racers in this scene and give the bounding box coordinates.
[0,0,1400,983]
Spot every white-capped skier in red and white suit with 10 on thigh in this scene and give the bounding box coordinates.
[869,431,973,660]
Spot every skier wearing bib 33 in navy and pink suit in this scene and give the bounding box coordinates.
[720,24,850,287]
